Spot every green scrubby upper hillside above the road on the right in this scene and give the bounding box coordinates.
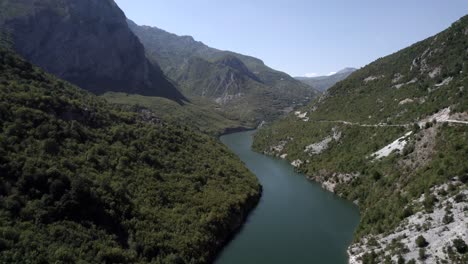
[311,17,468,124]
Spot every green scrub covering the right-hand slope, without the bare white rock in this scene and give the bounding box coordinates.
[254,14,468,260]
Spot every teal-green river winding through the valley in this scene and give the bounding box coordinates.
[215,131,359,264]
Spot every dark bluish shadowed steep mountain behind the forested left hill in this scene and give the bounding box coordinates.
[0,0,184,102]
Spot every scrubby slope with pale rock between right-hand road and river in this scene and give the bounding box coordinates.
[255,120,468,263]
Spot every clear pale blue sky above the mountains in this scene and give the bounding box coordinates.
[116,0,468,76]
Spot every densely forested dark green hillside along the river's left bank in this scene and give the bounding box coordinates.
[0,46,261,263]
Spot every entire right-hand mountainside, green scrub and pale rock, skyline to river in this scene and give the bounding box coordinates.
[254,16,468,263]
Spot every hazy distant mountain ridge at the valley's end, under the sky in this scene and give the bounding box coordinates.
[128,21,317,123]
